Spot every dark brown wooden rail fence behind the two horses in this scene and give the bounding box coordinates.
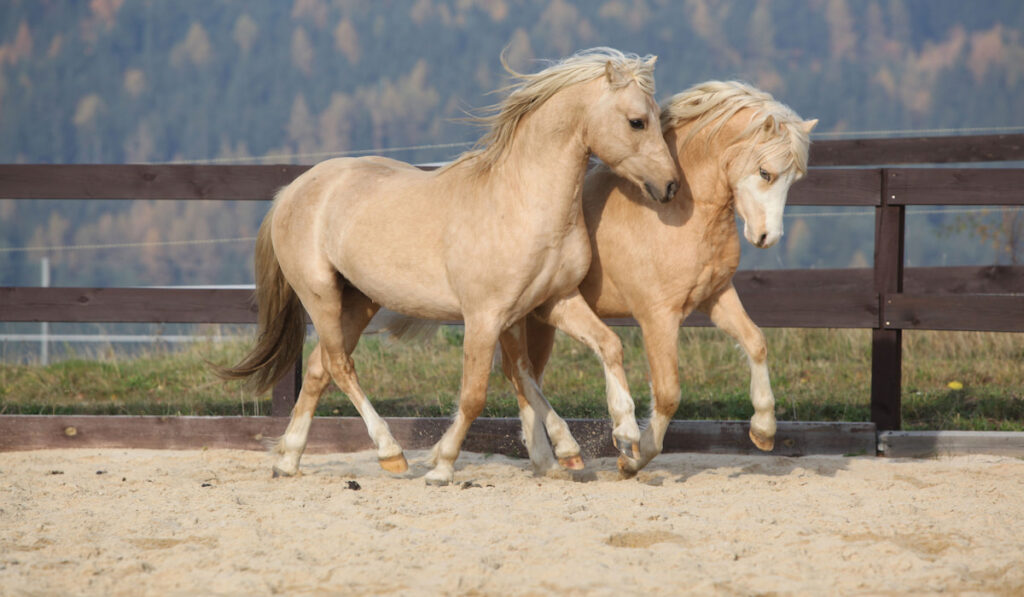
[0,134,1024,450]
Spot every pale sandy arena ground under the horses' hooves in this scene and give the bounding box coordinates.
[0,450,1024,596]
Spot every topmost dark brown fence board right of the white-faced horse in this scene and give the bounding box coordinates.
[810,134,1024,166]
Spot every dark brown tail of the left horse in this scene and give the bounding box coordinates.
[217,203,306,394]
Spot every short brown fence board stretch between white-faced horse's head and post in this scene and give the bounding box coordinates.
[786,168,882,206]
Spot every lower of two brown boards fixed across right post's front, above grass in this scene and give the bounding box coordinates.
[885,294,1024,332]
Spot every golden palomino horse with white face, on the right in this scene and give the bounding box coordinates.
[506,81,817,474]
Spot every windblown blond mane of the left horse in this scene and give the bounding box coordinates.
[442,47,654,172]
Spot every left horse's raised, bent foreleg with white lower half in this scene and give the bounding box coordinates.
[535,291,640,469]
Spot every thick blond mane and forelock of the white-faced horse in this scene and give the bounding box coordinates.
[662,81,810,174]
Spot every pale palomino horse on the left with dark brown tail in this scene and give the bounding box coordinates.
[222,48,678,484]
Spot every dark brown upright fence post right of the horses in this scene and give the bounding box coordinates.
[871,169,906,431]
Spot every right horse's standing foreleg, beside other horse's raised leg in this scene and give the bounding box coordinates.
[624,309,682,472]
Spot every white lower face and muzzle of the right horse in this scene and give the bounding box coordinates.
[734,172,795,249]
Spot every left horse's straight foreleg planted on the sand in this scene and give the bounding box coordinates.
[426,316,500,485]
